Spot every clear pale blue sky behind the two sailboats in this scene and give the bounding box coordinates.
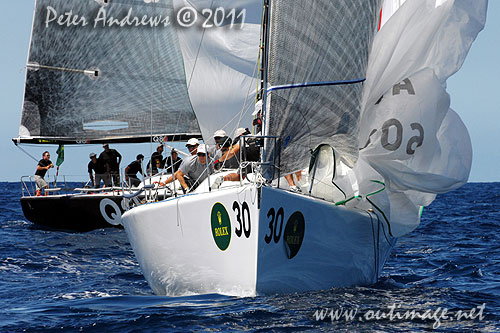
[0,0,500,182]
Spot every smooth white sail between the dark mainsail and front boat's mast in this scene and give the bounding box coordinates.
[174,0,262,141]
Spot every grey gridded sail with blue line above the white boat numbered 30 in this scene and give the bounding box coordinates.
[266,0,380,178]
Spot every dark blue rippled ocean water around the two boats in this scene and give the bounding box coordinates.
[0,183,500,332]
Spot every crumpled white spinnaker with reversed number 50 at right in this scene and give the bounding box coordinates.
[354,0,487,237]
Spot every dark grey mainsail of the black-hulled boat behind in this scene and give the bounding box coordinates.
[17,0,200,144]
